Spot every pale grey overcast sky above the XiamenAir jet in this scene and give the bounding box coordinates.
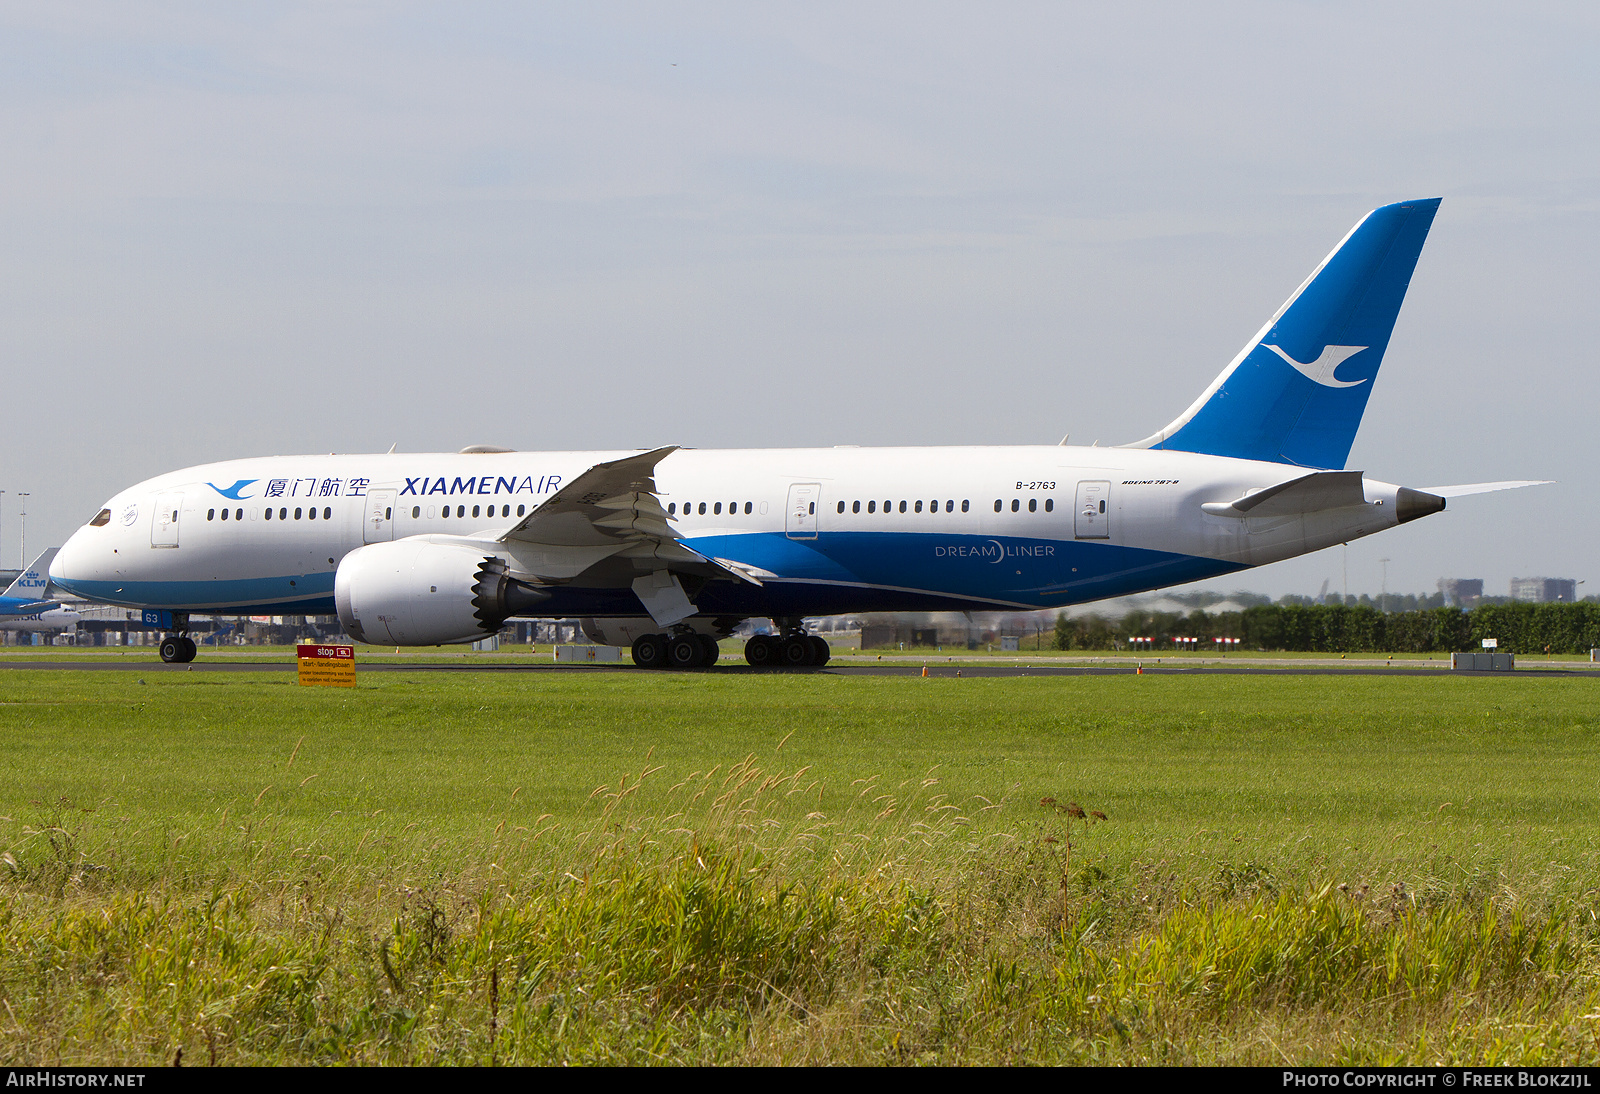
[0,0,1600,595]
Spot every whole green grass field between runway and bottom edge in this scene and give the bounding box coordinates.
[0,672,1600,1064]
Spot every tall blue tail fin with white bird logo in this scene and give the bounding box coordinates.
[1128,198,1440,469]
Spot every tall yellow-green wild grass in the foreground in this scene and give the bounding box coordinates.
[0,753,1600,1064]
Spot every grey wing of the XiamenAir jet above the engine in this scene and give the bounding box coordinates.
[501,445,760,584]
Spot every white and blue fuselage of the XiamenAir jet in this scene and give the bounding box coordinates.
[50,446,1397,617]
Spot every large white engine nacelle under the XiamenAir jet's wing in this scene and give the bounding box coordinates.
[333,536,549,646]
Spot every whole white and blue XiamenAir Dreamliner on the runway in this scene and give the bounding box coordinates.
[50,198,1528,669]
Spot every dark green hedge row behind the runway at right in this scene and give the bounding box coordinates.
[1054,600,1600,654]
